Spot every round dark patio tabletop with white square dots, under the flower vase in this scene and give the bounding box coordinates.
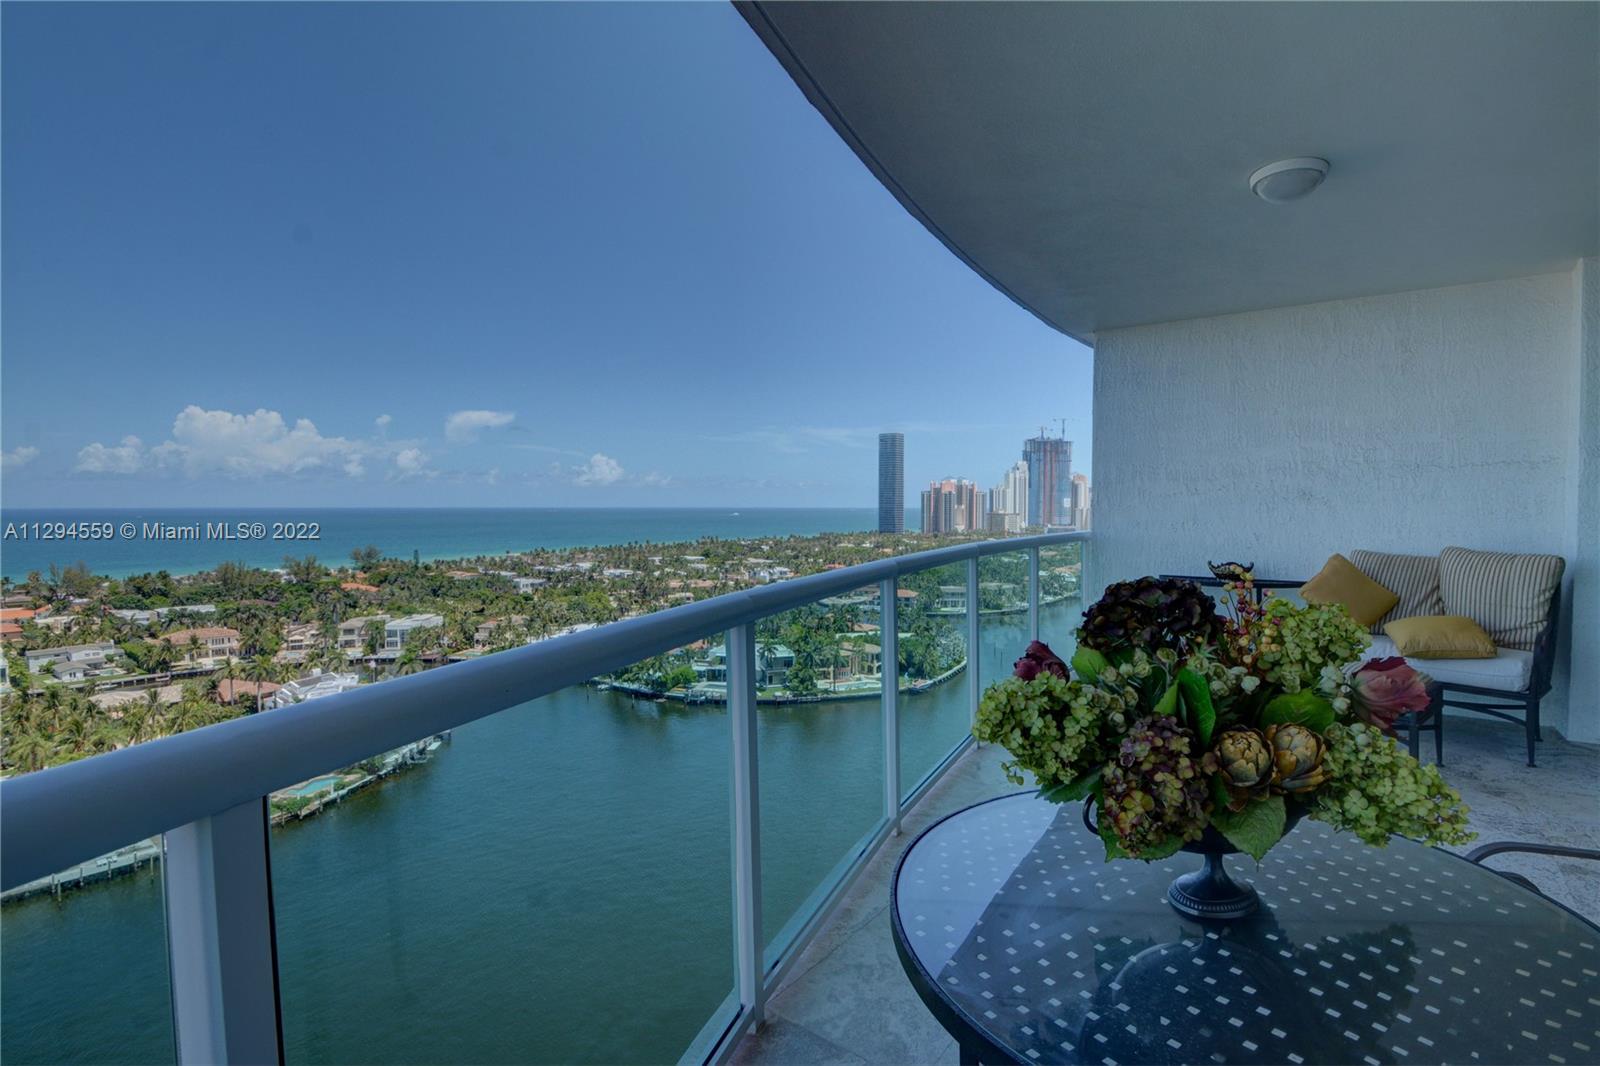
[890,792,1600,1064]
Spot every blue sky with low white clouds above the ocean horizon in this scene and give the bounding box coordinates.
[0,3,1091,507]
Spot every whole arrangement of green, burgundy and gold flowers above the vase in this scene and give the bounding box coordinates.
[973,563,1474,860]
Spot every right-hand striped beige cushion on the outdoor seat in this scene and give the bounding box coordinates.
[1438,547,1566,651]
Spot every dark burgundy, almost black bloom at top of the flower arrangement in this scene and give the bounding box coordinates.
[1078,578,1222,653]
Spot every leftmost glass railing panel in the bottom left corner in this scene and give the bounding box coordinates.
[0,839,174,1063]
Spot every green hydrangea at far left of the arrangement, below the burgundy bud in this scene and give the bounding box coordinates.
[973,674,1100,787]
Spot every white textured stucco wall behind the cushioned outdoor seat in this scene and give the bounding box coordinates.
[1090,269,1600,739]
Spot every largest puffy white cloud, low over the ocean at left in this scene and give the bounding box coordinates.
[75,403,373,477]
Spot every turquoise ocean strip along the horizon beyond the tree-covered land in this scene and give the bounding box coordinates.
[0,507,920,581]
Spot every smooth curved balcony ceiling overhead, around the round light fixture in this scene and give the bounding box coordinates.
[738,3,1600,341]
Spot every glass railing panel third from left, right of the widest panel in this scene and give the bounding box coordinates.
[755,586,904,964]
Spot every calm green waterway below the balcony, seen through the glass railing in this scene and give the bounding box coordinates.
[0,602,1082,1063]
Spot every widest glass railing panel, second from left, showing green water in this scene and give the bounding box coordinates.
[267,639,734,1064]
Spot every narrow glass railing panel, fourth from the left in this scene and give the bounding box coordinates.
[898,562,973,800]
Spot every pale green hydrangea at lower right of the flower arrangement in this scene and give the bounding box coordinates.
[1310,722,1477,847]
